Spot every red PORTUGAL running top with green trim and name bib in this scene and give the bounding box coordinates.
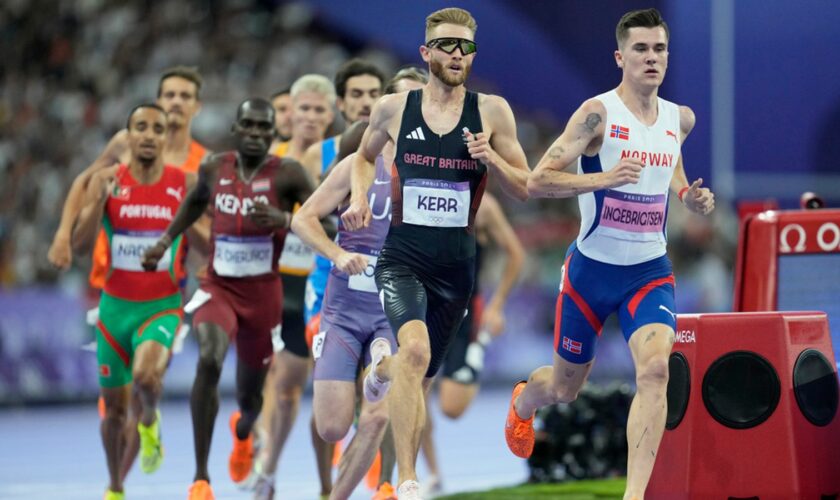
[102,165,187,301]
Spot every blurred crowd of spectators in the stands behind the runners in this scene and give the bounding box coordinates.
[0,0,737,312]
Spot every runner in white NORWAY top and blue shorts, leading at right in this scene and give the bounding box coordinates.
[505,9,714,499]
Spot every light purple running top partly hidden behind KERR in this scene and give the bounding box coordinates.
[331,155,391,293]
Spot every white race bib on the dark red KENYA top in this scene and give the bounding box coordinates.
[213,235,273,278]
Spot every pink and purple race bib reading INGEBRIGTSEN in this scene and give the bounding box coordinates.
[600,189,666,234]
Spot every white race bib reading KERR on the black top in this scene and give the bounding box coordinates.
[403,179,470,227]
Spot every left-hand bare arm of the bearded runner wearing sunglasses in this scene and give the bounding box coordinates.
[341,92,408,231]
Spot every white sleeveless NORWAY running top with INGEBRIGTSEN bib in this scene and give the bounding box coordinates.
[577,90,680,266]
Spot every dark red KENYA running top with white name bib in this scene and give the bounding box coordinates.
[208,152,286,279]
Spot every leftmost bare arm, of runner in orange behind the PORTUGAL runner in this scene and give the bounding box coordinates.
[47,130,129,269]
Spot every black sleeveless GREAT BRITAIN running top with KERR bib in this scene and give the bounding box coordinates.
[384,89,487,262]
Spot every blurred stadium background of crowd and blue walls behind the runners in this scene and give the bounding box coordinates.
[0,0,840,418]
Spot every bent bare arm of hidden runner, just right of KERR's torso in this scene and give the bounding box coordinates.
[475,193,525,337]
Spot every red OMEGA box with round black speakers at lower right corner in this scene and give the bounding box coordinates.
[645,312,840,500]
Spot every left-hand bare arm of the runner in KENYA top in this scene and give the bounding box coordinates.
[142,154,221,271]
